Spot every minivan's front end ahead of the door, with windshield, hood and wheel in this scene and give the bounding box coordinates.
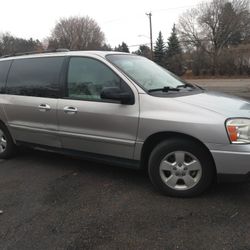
[108,52,250,197]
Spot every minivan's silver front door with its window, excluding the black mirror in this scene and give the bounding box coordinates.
[58,57,139,159]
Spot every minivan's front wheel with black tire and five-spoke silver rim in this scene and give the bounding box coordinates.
[148,139,215,197]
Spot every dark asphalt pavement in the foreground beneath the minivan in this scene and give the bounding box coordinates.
[0,81,250,250]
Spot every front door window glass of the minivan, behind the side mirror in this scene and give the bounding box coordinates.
[68,57,121,101]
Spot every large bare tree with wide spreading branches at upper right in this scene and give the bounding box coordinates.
[178,0,250,73]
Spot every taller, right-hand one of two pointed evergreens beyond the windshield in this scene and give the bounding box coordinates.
[165,24,184,75]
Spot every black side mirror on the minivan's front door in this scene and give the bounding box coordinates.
[101,87,134,104]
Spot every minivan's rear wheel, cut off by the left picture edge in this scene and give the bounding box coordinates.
[0,124,15,159]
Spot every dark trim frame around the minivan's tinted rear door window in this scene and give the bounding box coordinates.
[4,56,67,99]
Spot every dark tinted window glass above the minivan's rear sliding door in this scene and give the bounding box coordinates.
[6,57,64,98]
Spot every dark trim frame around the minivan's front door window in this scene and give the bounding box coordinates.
[62,55,135,105]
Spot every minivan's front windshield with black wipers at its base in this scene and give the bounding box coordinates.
[106,54,195,92]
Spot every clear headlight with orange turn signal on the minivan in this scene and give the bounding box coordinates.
[226,118,250,144]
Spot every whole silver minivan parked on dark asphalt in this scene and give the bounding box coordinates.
[0,51,250,197]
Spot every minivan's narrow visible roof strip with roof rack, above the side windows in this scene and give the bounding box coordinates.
[0,50,131,61]
